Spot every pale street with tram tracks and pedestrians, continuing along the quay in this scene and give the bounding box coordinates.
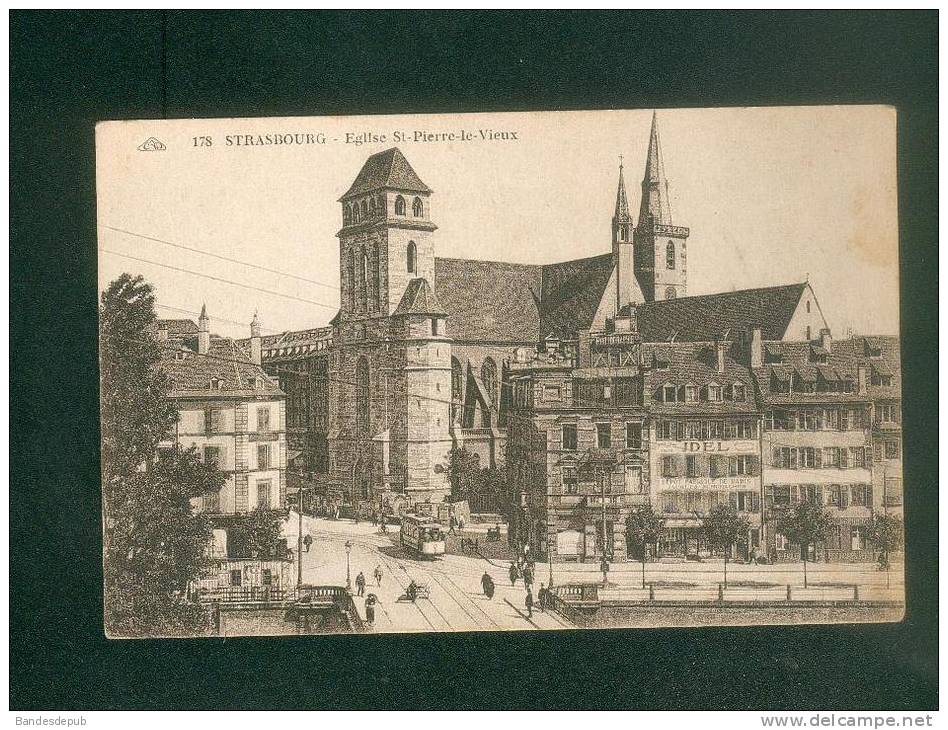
[283,512,902,632]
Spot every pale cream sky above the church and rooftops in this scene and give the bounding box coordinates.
[96,106,899,337]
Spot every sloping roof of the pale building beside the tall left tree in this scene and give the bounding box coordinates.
[160,336,283,397]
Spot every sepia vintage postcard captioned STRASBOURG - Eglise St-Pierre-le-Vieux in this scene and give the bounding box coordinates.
[96,106,904,638]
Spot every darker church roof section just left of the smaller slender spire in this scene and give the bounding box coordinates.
[540,253,614,338]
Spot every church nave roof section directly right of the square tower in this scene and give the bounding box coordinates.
[434,258,541,344]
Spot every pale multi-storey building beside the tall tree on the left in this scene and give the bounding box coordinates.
[158,308,286,521]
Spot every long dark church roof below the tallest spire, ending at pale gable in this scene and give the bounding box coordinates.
[635,283,807,342]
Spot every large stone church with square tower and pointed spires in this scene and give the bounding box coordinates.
[314,115,826,504]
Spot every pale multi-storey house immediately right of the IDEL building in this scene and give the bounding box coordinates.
[750,329,881,560]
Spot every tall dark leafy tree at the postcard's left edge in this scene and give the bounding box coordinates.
[99,274,224,637]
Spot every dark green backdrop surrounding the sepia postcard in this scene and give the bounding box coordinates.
[10,11,938,709]
